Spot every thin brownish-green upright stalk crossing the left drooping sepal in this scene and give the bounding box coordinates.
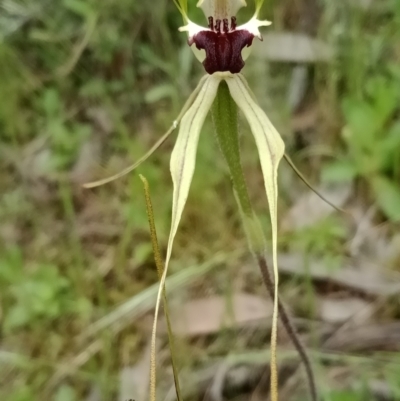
[139,174,182,401]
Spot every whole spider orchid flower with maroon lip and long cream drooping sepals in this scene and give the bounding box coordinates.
[86,0,284,400]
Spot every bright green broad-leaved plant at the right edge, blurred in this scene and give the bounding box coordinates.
[322,74,400,221]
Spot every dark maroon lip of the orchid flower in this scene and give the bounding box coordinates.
[189,17,254,74]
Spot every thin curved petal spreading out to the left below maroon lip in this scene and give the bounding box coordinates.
[83,75,208,188]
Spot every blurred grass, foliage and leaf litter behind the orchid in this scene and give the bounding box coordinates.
[0,0,400,401]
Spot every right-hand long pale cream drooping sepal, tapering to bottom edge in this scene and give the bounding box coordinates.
[226,74,285,401]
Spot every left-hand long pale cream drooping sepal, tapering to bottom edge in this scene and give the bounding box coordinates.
[150,75,221,401]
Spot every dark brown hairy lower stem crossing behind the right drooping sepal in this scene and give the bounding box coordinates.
[256,254,318,401]
